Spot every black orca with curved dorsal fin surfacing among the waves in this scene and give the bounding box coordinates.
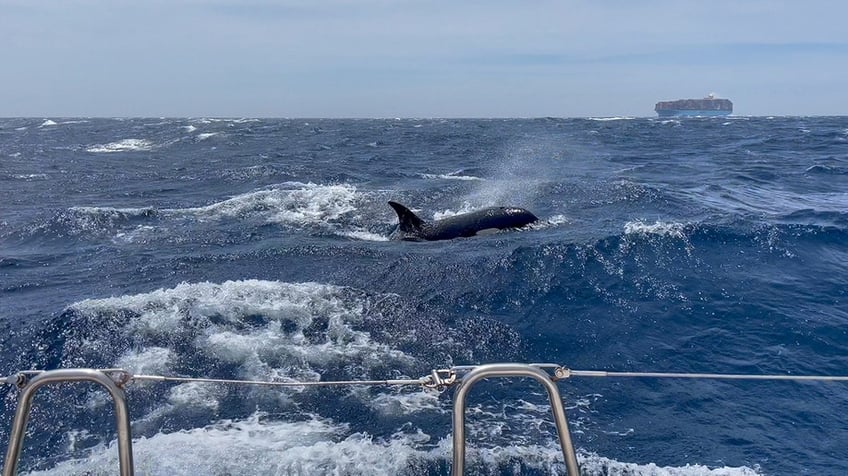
[389,202,538,241]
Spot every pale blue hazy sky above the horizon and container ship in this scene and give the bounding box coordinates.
[0,0,848,118]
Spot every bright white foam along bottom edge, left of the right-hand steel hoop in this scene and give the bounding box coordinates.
[30,413,446,476]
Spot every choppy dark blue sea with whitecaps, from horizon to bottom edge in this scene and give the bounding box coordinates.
[0,117,848,476]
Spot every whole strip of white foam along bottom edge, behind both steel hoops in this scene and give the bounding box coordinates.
[23,413,762,476]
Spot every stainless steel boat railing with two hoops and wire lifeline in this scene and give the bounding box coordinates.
[6,363,848,476]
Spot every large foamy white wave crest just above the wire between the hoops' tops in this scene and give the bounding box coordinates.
[66,280,409,380]
